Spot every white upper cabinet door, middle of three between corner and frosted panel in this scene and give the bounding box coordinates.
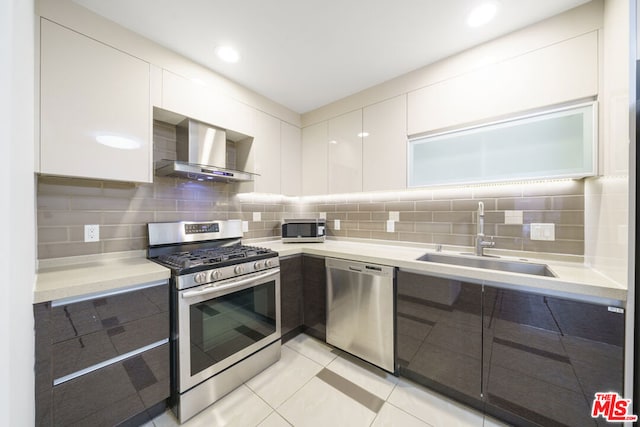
[328,110,362,194]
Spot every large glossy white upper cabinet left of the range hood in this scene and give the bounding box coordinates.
[39,19,153,182]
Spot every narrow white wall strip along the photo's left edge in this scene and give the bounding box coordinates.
[0,0,35,426]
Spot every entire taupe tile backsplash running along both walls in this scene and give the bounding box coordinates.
[37,118,585,259]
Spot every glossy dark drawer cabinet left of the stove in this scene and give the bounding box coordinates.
[34,282,170,426]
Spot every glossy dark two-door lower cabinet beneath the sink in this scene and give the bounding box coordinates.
[397,270,624,427]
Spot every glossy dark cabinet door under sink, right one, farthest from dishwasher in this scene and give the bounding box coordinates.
[483,286,624,427]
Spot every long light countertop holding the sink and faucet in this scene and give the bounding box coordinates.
[255,240,627,306]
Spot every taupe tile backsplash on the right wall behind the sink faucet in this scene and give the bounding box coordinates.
[301,181,584,255]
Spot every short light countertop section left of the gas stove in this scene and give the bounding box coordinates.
[33,251,171,304]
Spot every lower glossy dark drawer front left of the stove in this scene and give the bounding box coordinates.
[53,343,169,427]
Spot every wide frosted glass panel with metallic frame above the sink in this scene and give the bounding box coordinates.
[408,102,597,187]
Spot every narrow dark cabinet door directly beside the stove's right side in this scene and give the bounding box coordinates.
[280,255,303,343]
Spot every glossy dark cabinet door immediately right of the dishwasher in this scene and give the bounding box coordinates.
[397,271,482,408]
